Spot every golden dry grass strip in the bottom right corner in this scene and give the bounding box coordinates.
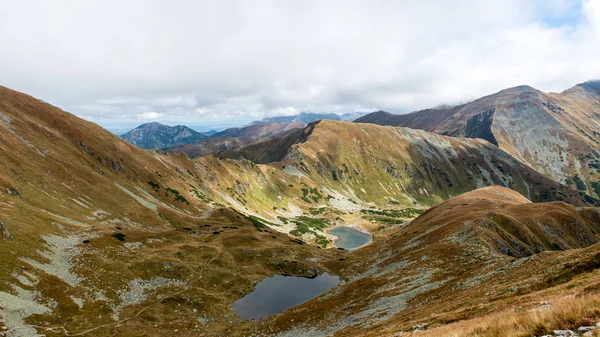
[418,293,600,337]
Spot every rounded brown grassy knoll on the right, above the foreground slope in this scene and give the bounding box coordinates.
[407,187,600,257]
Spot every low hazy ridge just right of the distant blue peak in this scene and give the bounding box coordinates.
[165,122,306,157]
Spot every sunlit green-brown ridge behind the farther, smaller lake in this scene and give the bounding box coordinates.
[207,120,598,238]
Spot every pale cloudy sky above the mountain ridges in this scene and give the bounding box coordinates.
[0,0,600,126]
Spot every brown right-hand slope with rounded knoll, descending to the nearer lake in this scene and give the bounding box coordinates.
[268,187,600,336]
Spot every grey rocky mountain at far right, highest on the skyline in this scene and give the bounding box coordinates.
[356,81,600,197]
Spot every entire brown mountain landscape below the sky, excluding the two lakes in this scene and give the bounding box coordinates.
[0,82,600,337]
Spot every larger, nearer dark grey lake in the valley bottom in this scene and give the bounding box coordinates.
[233,273,340,320]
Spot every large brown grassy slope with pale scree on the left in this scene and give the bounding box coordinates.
[0,87,338,337]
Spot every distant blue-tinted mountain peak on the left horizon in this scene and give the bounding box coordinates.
[121,122,207,149]
